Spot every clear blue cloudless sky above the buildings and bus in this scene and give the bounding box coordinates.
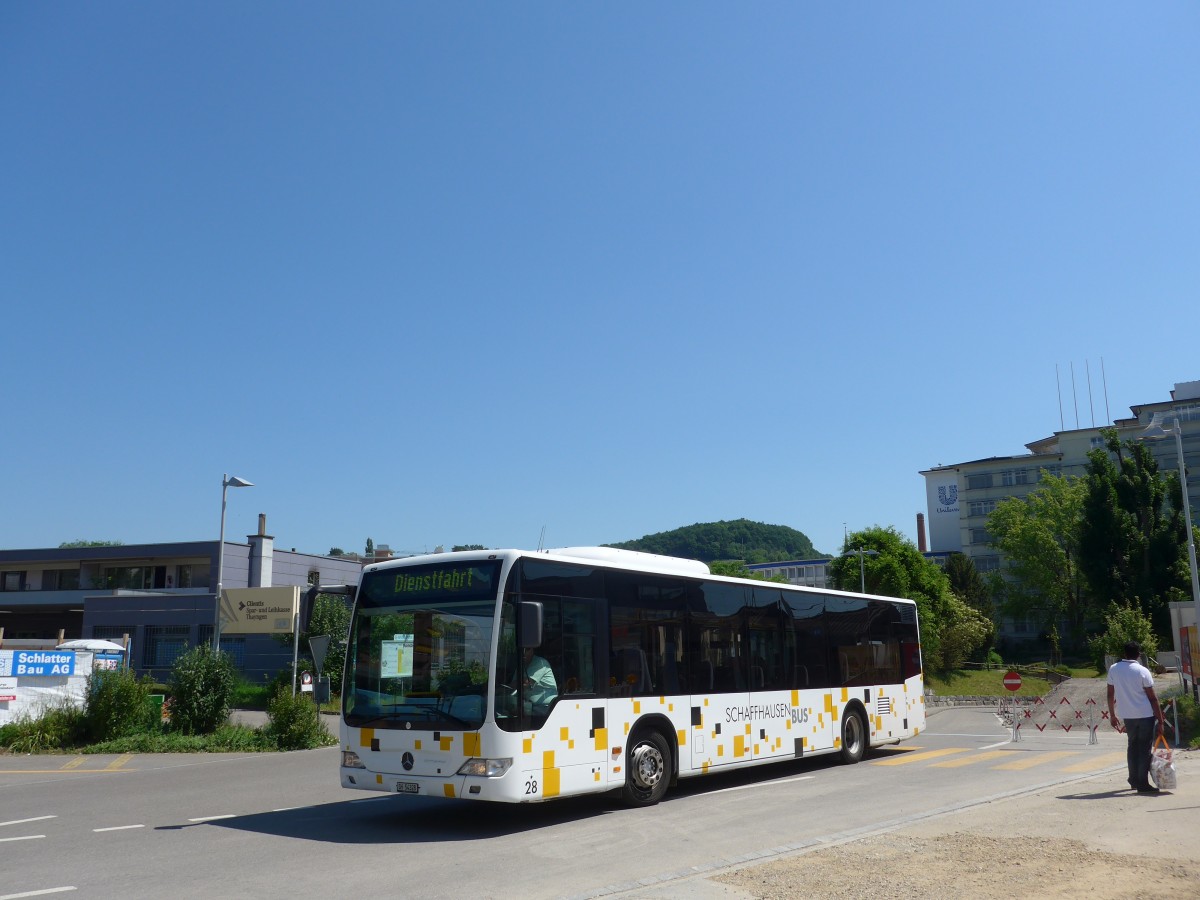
[0,1,1200,561]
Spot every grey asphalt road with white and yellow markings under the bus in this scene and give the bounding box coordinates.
[0,709,1124,900]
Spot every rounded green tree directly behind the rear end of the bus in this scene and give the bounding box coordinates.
[829,526,991,670]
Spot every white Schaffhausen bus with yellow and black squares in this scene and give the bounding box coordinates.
[341,547,925,805]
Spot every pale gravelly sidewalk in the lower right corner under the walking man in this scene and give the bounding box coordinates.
[700,751,1200,900]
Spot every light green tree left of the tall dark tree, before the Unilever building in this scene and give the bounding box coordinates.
[988,472,1093,646]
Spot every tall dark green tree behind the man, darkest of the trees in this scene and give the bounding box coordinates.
[1079,428,1188,634]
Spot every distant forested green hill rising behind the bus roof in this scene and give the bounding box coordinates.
[607,518,821,563]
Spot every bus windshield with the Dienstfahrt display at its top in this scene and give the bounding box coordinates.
[342,560,500,731]
